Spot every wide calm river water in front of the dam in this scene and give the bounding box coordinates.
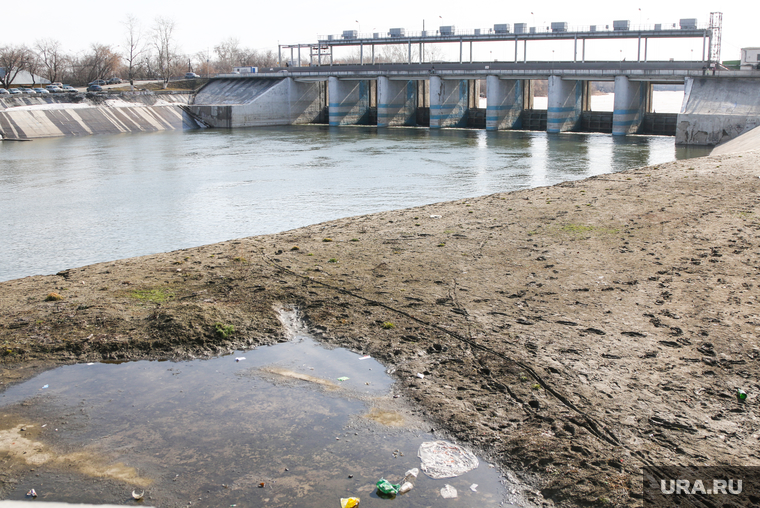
[0,125,706,281]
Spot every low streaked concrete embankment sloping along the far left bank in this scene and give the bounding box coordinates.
[0,93,199,140]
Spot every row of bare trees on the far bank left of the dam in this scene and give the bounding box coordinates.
[0,16,278,88]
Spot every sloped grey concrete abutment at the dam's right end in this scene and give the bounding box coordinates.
[676,77,760,145]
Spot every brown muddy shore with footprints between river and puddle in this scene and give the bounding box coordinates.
[0,148,760,506]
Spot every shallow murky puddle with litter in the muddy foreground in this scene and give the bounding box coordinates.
[0,310,506,508]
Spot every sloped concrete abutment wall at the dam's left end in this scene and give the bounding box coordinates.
[189,78,327,128]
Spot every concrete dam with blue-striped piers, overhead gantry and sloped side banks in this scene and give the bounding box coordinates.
[0,13,760,145]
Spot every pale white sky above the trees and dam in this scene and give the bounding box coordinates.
[0,0,760,64]
